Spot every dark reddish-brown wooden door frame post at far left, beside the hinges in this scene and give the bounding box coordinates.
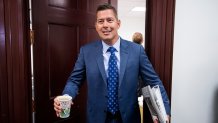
[0,0,31,123]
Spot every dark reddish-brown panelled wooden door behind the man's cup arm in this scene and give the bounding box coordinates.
[32,0,117,123]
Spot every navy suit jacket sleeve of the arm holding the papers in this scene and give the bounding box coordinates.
[140,46,170,115]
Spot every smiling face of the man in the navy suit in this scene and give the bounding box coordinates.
[95,9,120,44]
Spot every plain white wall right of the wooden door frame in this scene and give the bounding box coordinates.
[171,0,218,123]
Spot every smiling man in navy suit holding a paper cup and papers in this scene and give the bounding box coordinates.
[54,4,170,123]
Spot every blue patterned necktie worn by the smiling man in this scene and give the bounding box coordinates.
[107,47,119,114]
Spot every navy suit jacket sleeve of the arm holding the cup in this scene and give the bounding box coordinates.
[62,48,86,99]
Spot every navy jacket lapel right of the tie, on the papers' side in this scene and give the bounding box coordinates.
[119,38,129,86]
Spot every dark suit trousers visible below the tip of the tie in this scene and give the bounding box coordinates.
[105,112,122,123]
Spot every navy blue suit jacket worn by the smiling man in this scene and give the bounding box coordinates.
[63,39,170,123]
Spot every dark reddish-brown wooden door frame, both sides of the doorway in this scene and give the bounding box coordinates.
[0,0,175,123]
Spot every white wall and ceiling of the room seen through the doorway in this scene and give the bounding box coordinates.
[118,0,146,41]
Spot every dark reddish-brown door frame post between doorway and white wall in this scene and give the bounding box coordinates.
[144,0,176,122]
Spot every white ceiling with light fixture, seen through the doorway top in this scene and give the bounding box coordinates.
[118,0,146,18]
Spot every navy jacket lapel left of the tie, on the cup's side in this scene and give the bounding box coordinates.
[94,41,107,85]
